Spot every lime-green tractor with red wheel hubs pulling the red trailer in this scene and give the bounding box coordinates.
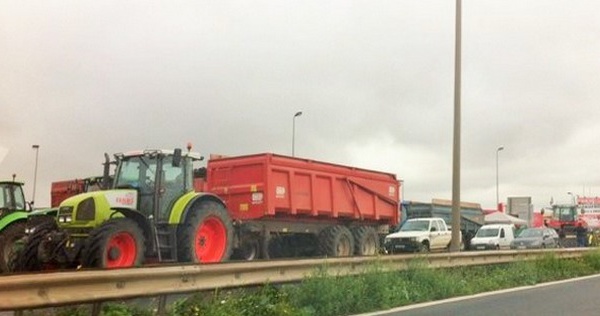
[15,147,233,271]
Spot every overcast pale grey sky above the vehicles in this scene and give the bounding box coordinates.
[0,0,600,209]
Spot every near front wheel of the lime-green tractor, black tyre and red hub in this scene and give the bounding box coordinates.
[81,218,146,269]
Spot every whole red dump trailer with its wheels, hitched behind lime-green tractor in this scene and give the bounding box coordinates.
[205,154,400,260]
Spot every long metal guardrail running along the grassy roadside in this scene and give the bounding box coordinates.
[0,248,589,311]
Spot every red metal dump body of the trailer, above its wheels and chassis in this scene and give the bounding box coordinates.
[207,154,399,225]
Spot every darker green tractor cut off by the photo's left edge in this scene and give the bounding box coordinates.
[0,181,31,273]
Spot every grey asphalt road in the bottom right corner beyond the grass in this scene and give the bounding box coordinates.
[362,275,600,316]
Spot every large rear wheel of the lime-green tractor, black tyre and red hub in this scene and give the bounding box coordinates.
[177,201,233,263]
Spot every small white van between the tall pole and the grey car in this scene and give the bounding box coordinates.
[470,224,515,250]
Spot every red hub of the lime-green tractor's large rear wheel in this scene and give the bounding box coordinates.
[194,217,227,262]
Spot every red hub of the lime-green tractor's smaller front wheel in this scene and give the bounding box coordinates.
[105,232,137,268]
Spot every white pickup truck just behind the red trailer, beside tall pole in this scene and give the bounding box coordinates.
[384,217,460,254]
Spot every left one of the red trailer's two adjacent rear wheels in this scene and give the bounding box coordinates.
[319,225,354,257]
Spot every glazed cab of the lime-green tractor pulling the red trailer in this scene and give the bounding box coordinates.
[113,149,202,222]
